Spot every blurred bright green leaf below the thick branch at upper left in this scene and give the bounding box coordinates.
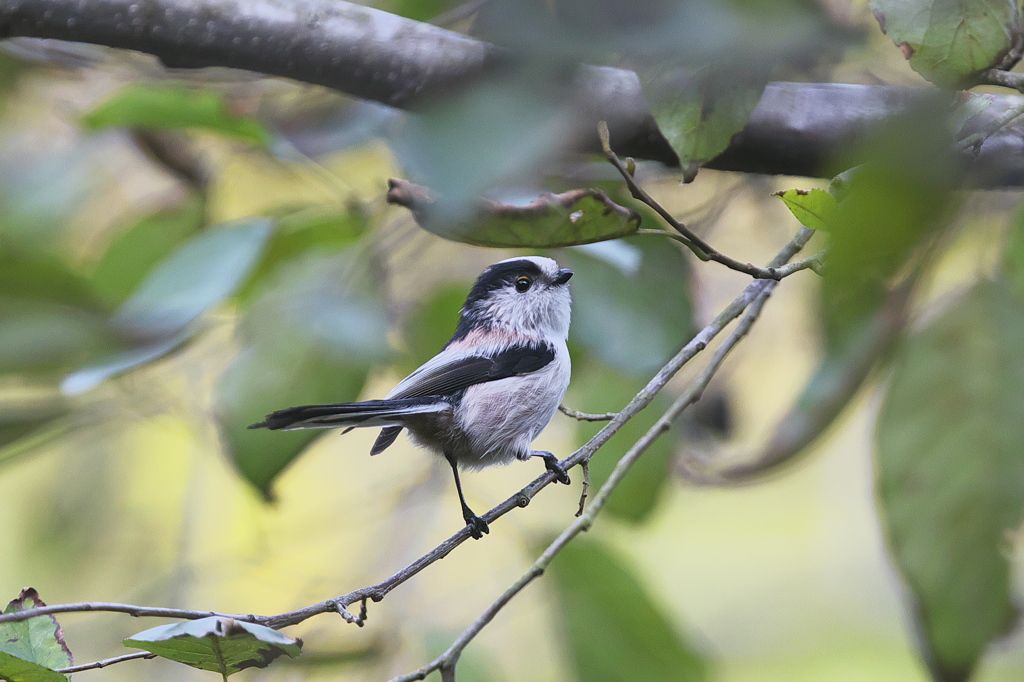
[82,85,271,146]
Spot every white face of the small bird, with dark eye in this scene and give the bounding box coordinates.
[478,256,572,340]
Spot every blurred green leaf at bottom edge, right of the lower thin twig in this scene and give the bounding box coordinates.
[546,537,708,682]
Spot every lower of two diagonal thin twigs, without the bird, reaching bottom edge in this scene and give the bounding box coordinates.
[391,236,777,682]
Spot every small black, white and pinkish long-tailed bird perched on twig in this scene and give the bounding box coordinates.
[249,256,572,540]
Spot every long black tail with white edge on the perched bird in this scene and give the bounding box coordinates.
[249,396,449,431]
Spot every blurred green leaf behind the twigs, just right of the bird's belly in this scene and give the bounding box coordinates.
[570,360,673,523]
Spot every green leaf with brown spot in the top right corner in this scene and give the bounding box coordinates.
[871,0,1020,89]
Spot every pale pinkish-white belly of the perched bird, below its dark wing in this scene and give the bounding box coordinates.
[458,343,570,468]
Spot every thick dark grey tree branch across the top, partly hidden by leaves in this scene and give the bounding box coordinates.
[6,0,1024,185]
